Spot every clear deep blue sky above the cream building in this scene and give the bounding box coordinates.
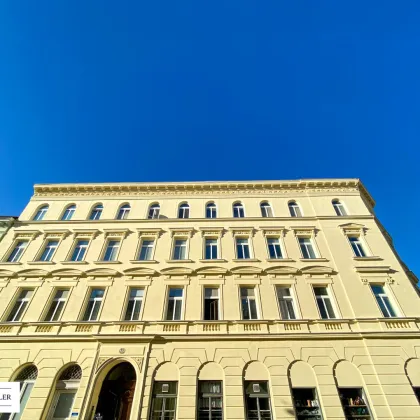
[0,0,420,274]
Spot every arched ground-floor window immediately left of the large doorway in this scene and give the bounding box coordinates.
[48,365,82,420]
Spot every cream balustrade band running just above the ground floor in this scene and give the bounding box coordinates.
[0,318,420,338]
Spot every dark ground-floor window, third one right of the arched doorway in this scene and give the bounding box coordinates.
[244,381,272,420]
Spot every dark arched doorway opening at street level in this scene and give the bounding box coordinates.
[96,362,136,420]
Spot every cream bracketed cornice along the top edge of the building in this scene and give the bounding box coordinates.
[34,178,375,207]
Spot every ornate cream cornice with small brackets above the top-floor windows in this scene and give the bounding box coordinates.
[34,178,375,207]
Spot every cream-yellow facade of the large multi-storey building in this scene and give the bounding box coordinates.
[0,179,420,420]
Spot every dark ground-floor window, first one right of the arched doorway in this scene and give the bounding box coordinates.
[150,381,178,420]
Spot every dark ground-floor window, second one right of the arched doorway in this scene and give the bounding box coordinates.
[197,381,223,420]
